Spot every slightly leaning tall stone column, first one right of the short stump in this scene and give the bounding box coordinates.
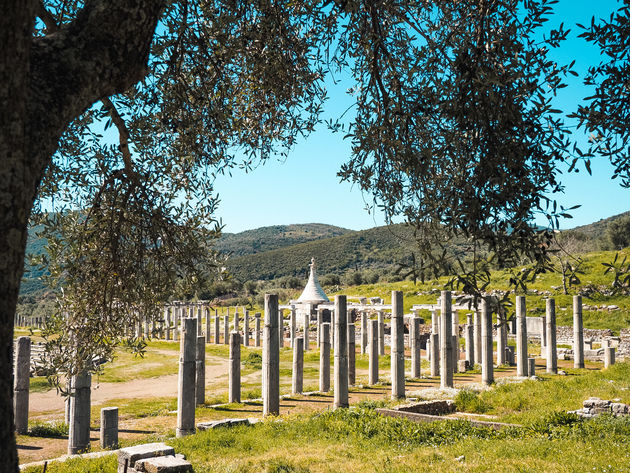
[175,317,197,437]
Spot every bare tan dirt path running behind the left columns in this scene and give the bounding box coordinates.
[29,356,229,416]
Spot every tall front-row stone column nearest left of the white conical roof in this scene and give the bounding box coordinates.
[262,294,280,416]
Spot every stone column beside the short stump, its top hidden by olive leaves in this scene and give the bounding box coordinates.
[68,372,92,455]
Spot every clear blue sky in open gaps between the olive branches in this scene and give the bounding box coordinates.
[215,0,630,233]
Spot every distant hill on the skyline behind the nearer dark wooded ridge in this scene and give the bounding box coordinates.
[215,223,353,256]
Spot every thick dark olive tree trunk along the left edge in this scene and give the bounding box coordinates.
[0,0,164,472]
